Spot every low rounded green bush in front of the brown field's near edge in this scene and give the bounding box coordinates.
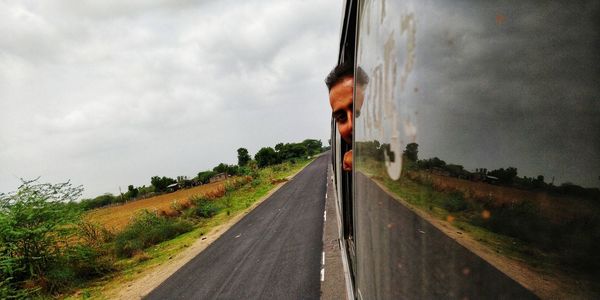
[114,210,193,257]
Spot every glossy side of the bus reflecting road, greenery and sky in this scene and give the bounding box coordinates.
[334,1,600,299]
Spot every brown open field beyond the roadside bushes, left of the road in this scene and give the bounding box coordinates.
[85,179,231,232]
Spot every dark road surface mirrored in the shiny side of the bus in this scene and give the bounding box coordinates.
[355,173,537,299]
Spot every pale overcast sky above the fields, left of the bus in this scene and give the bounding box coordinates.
[0,0,342,197]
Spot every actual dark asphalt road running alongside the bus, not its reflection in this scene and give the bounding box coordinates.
[146,155,329,300]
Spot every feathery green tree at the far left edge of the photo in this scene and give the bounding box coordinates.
[0,180,83,292]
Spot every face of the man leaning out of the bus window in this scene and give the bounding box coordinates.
[329,76,354,144]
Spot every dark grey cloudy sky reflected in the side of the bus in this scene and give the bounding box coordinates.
[355,0,600,187]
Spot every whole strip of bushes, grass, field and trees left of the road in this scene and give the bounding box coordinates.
[0,140,323,299]
